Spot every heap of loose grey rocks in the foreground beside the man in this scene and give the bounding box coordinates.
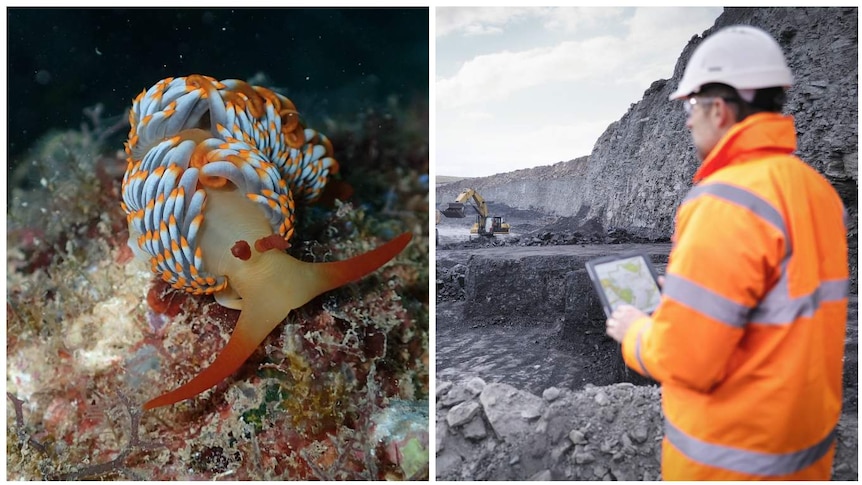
[435,377,858,481]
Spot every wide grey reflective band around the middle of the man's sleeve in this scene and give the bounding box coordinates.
[662,273,751,328]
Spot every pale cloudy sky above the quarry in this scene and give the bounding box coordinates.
[435,7,722,177]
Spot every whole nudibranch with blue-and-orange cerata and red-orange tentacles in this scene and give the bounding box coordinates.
[122,75,411,409]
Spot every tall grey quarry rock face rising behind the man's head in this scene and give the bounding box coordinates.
[436,7,858,293]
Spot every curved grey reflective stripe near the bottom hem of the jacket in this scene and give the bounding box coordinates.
[664,419,836,476]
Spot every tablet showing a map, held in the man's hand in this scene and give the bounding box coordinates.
[586,253,661,318]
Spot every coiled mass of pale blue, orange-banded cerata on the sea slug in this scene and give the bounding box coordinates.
[122,75,338,294]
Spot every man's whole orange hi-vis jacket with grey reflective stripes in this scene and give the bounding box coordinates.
[623,113,848,480]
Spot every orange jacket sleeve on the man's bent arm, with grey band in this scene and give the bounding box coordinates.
[623,183,785,392]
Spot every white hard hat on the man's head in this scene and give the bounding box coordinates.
[669,25,793,99]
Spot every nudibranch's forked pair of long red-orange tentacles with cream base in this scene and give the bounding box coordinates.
[144,233,412,409]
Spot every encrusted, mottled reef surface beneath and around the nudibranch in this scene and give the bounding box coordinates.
[7,96,429,480]
